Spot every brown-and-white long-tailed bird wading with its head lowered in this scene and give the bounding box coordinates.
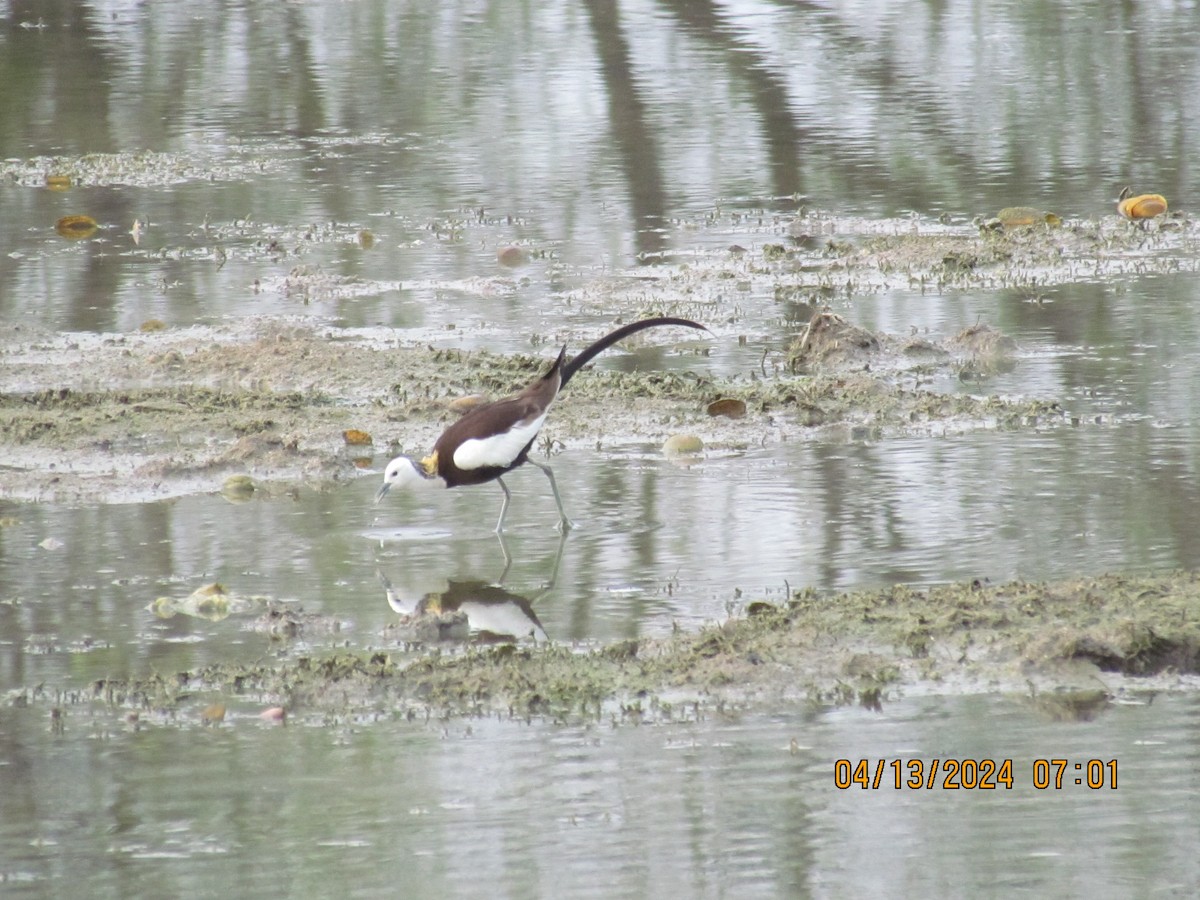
[376,316,708,532]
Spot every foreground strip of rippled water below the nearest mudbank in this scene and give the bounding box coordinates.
[0,696,1200,898]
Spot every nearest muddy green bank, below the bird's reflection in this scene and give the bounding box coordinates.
[18,574,1200,724]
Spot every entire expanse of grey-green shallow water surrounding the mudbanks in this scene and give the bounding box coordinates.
[0,0,1200,896]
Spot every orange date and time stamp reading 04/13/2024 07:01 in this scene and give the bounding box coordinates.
[833,758,1117,791]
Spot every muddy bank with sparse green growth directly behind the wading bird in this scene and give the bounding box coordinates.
[0,317,1069,502]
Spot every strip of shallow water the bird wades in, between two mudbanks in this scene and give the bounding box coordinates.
[0,421,1200,686]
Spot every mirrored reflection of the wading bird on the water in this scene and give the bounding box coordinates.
[378,533,566,643]
